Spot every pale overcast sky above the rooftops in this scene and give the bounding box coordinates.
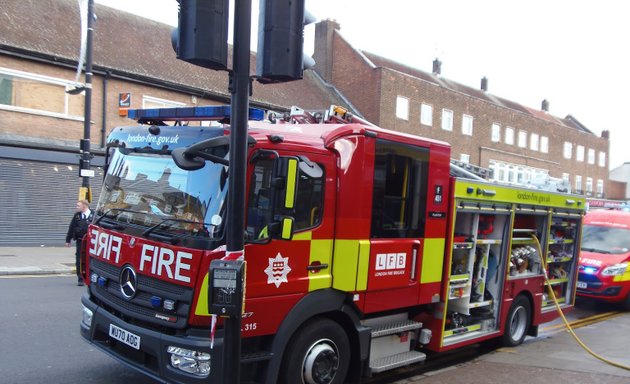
[96,0,630,168]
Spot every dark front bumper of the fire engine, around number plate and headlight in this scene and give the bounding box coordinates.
[81,293,223,384]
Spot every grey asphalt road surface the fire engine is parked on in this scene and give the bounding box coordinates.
[0,276,616,384]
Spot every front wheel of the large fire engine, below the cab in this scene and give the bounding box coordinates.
[280,319,350,384]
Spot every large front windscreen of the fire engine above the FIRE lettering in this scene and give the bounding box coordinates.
[97,148,227,238]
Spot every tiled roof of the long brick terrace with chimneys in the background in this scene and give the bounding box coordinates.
[362,51,593,134]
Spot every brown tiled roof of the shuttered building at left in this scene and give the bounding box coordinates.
[0,0,345,109]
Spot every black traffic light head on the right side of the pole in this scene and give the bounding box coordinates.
[256,0,315,83]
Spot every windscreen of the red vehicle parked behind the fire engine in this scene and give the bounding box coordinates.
[582,225,630,254]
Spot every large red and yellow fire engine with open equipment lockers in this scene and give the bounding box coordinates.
[81,106,586,384]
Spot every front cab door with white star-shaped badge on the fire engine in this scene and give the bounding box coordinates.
[245,151,335,298]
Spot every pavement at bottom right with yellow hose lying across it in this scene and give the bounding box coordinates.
[394,313,630,384]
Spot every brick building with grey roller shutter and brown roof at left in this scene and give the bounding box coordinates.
[0,0,347,246]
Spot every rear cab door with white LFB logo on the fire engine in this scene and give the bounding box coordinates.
[365,140,429,312]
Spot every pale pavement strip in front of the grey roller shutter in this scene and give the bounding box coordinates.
[0,248,76,276]
